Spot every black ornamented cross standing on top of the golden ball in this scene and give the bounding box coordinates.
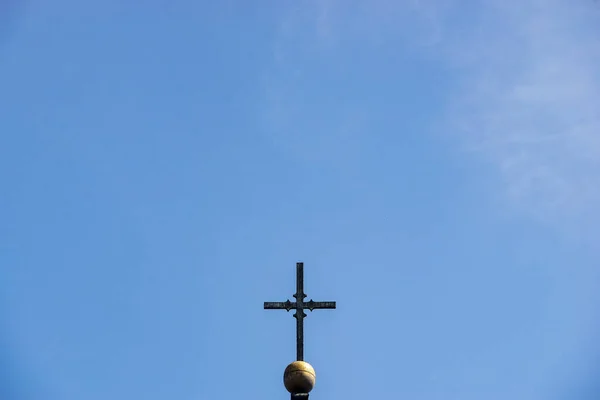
[265,263,335,361]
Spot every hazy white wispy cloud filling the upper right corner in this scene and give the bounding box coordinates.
[443,0,600,227]
